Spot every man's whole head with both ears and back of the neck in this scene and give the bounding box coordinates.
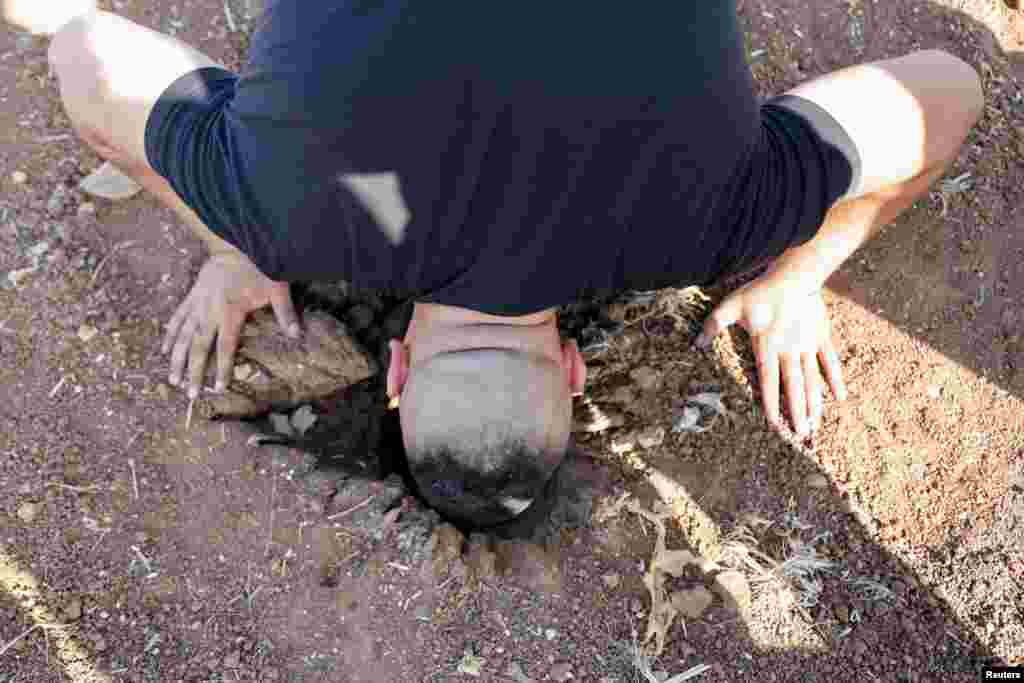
[388,305,586,526]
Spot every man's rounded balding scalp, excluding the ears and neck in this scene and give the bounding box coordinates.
[400,348,572,526]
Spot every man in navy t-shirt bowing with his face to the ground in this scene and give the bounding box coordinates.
[6,0,983,524]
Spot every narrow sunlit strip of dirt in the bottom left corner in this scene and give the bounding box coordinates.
[0,546,111,683]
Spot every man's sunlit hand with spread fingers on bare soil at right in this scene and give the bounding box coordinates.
[694,270,846,436]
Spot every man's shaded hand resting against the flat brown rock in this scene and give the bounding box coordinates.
[162,253,301,398]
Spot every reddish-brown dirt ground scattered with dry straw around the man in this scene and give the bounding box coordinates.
[0,0,1024,683]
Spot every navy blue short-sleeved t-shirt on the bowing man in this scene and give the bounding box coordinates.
[146,0,856,314]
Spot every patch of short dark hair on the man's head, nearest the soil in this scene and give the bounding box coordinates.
[406,439,564,530]
